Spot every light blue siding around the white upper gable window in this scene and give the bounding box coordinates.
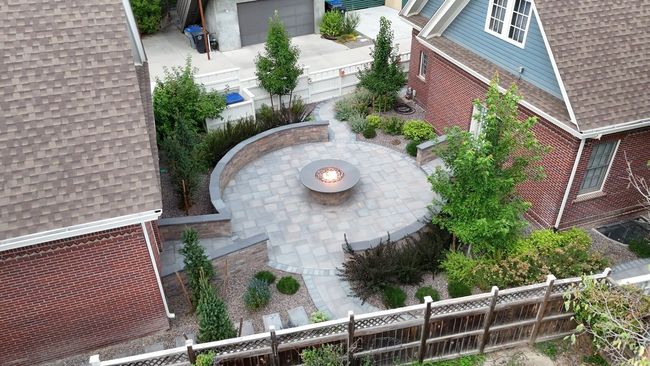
[440,0,562,99]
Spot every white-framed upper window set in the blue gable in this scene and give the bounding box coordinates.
[485,0,532,47]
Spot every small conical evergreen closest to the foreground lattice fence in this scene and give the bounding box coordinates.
[196,271,237,342]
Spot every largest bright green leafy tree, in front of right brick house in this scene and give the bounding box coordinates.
[429,78,548,257]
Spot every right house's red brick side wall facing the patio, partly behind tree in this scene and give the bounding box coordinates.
[409,33,579,227]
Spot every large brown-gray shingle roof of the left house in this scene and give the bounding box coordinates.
[0,0,162,240]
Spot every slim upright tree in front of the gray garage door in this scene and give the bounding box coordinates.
[255,11,303,107]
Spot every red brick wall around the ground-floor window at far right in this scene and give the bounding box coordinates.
[560,128,650,227]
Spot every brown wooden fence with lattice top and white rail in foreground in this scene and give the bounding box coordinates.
[90,269,610,366]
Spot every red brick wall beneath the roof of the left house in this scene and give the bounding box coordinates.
[0,225,169,365]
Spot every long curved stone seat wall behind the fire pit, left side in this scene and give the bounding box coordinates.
[210,121,329,213]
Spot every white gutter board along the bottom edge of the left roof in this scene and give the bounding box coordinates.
[0,210,162,252]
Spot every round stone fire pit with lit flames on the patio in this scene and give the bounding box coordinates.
[300,159,360,205]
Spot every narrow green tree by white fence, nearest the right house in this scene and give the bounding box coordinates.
[359,17,406,110]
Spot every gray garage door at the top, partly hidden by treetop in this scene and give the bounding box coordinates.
[237,0,314,46]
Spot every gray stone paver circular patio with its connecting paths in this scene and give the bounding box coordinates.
[223,101,433,317]
